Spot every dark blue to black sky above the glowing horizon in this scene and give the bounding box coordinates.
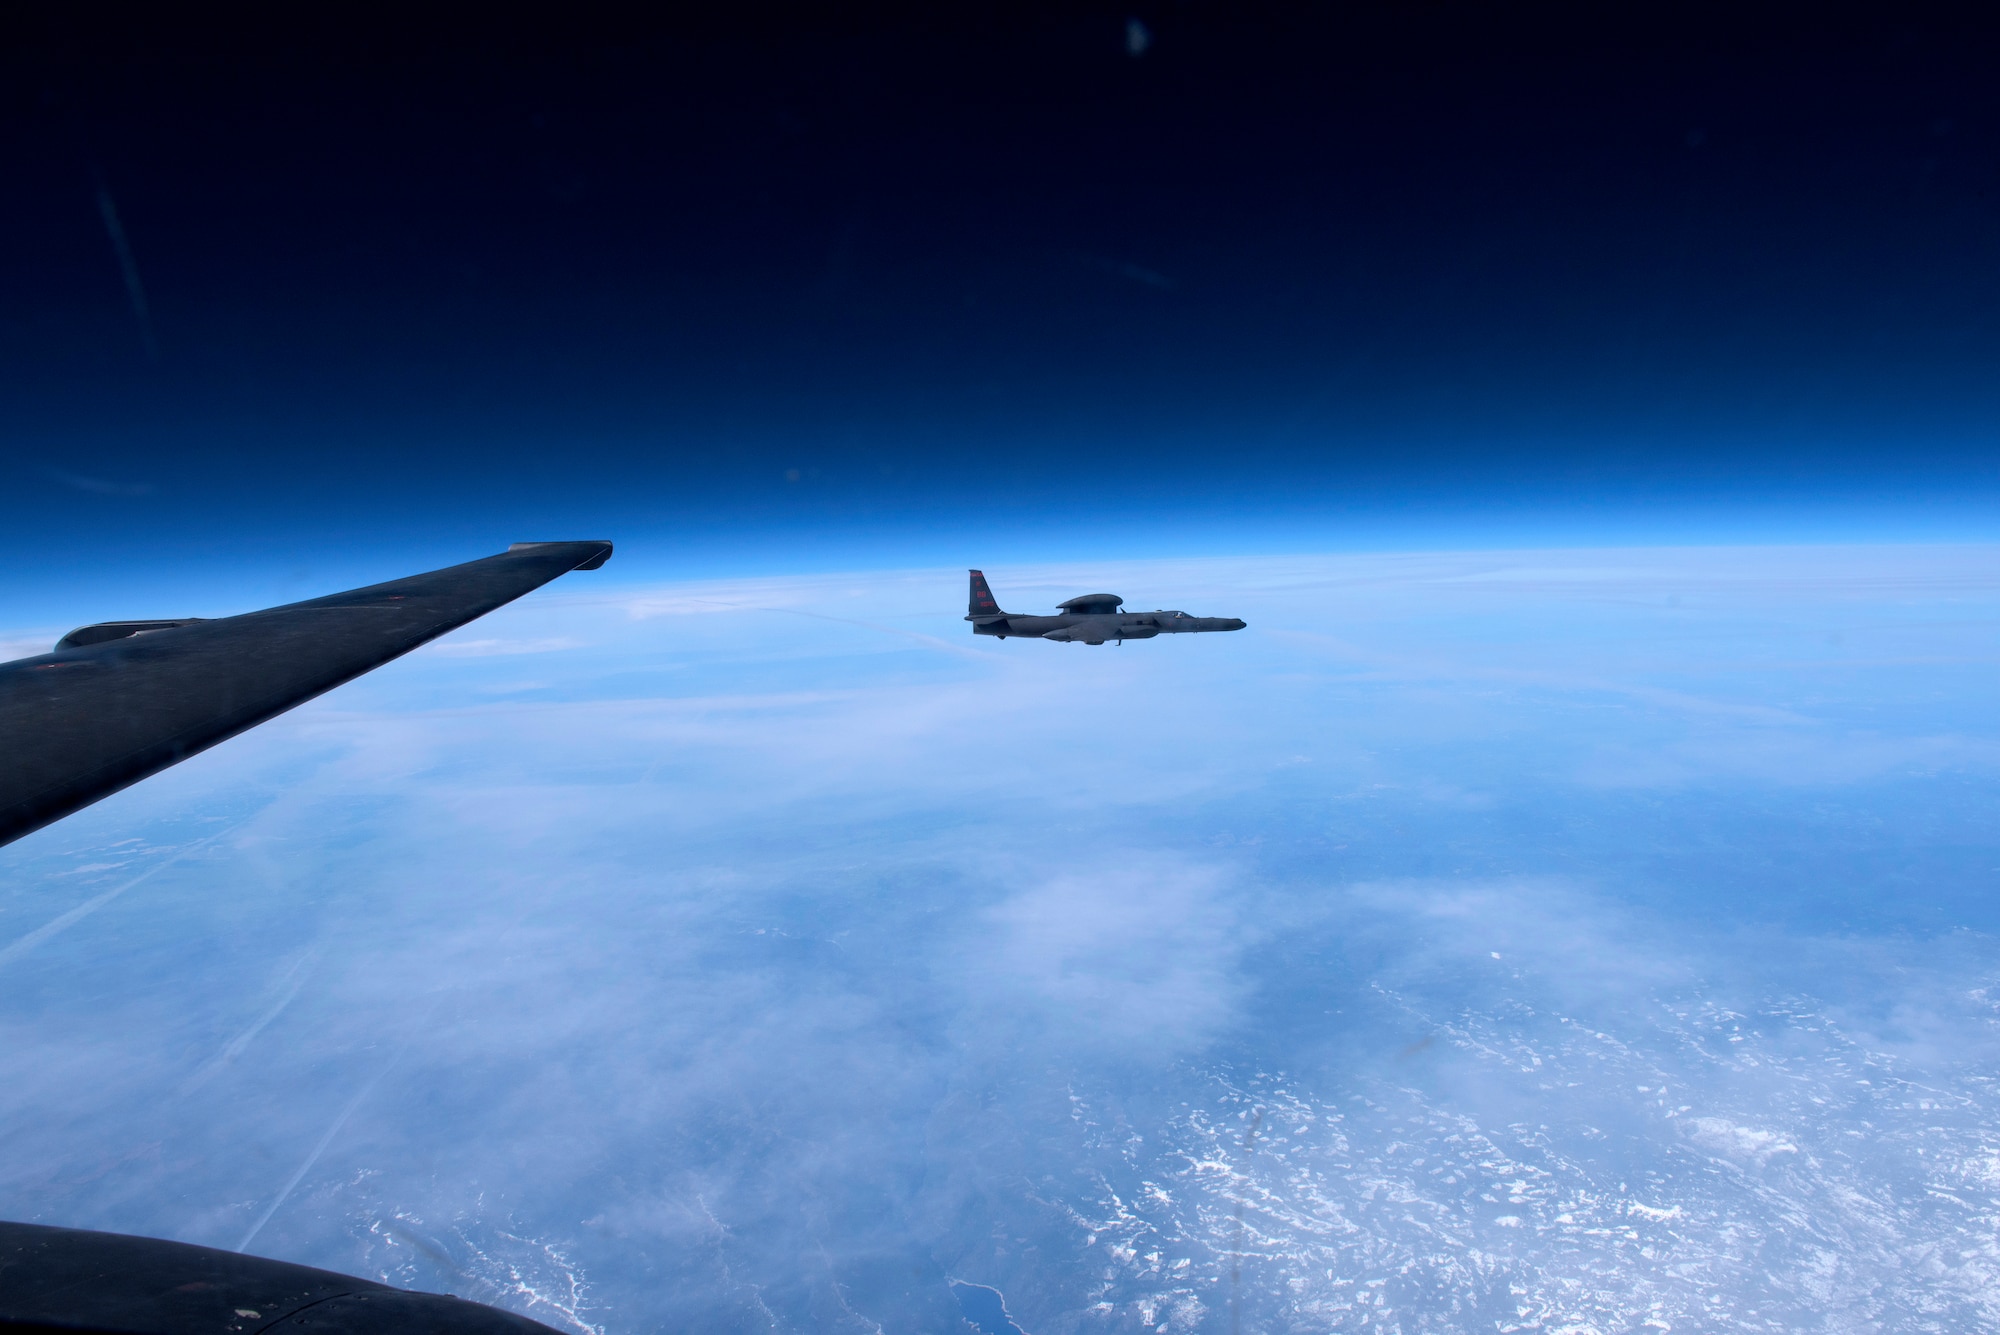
[0,4,2000,603]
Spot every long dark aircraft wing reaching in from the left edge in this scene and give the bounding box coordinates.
[0,542,612,843]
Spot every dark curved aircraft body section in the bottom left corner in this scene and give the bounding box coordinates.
[0,1223,554,1335]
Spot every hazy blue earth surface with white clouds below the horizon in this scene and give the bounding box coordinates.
[0,548,2000,1335]
